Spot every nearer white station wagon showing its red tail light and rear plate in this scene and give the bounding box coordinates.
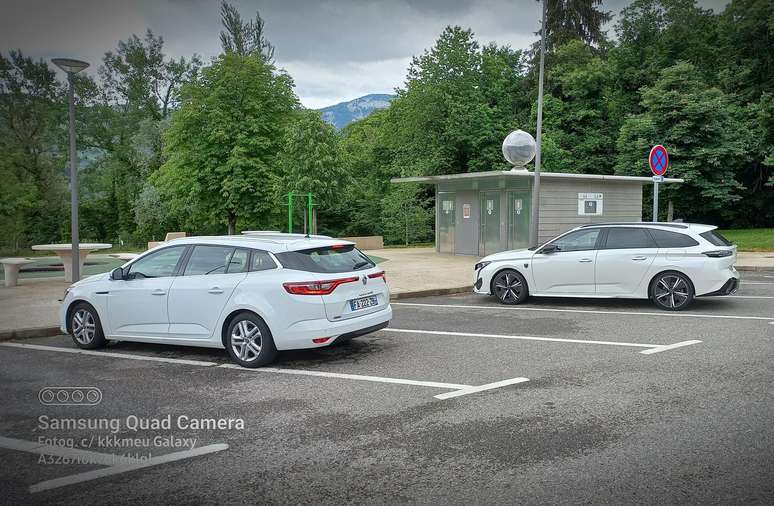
[60,233,392,367]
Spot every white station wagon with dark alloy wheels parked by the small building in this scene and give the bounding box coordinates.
[474,222,739,311]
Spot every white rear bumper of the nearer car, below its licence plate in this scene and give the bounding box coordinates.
[274,304,392,350]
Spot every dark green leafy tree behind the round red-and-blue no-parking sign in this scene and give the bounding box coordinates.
[616,62,746,222]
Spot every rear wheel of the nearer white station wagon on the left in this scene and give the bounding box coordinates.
[226,312,277,368]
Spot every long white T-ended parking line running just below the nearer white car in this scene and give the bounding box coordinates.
[0,343,529,397]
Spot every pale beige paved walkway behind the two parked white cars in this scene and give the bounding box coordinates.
[0,248,774,335]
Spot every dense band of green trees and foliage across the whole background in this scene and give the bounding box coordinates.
[0,0,774,250]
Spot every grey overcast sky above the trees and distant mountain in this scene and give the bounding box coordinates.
[0,0,728,108]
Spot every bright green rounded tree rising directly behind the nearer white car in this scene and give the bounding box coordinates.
[158,53,298,234]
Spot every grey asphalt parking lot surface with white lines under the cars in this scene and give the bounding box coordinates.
[0,272,774,504]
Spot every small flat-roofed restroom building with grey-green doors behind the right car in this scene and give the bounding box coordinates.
[392,170,683,256]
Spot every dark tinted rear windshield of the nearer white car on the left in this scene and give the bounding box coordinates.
[276,244,374,273]
